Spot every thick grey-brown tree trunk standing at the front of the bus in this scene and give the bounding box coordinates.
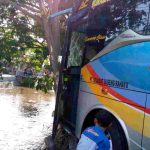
[40,0,61,74]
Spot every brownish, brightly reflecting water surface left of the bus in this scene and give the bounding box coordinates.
[0,87,55,150]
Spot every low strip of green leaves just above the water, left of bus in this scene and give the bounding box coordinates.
[21,75,54,93]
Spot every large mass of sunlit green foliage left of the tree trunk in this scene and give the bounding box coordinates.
[0,0,48,72]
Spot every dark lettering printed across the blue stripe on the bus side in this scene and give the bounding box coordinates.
[90,77,128,89]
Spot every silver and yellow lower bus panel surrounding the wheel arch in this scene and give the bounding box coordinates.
[76,79,144,150]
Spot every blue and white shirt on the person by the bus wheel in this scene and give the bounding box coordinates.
[77,126,110,150]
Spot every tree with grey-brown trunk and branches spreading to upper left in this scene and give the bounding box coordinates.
[0,0,73,73]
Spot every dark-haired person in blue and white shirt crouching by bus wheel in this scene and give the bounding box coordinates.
[76,110,112,150]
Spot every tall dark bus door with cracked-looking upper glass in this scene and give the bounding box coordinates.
[61,22,85,131]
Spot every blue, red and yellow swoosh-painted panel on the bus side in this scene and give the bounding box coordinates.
[78,42,150,149]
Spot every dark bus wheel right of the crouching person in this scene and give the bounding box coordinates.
[107,118,128,150]
